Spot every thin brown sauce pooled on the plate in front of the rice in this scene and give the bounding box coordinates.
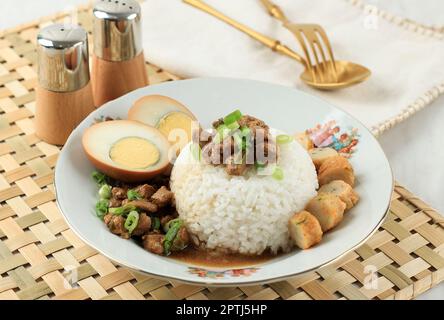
[170,247,282,268]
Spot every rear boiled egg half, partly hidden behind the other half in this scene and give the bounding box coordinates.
[128,95,197,149]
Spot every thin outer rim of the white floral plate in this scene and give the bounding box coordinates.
[53,77,395,287]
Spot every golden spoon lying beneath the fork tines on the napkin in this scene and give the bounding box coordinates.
[183,0,370,90]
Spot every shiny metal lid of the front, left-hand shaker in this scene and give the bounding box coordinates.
[37,24,89,92]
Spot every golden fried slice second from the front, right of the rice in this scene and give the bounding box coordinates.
[305,193,346,232]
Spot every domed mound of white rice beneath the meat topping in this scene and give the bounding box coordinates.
[170,136,318,254]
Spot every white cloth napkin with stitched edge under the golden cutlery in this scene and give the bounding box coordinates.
[142,0,444,129]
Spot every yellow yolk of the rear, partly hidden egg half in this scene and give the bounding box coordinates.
[157,112,193,145]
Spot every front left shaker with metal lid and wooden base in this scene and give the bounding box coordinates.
[35,24,95,145]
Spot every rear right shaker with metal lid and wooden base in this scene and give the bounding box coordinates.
[92,0,148,106]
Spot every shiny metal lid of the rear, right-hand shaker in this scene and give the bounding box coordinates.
[93,0,142,61]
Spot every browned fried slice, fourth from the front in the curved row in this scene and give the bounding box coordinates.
[318,156,355,187]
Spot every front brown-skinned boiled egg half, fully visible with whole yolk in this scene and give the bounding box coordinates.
[82,120,170,182]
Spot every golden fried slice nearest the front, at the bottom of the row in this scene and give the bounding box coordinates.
[288,211,323,249]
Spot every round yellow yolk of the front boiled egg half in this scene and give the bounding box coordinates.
[109,137,160,169]
